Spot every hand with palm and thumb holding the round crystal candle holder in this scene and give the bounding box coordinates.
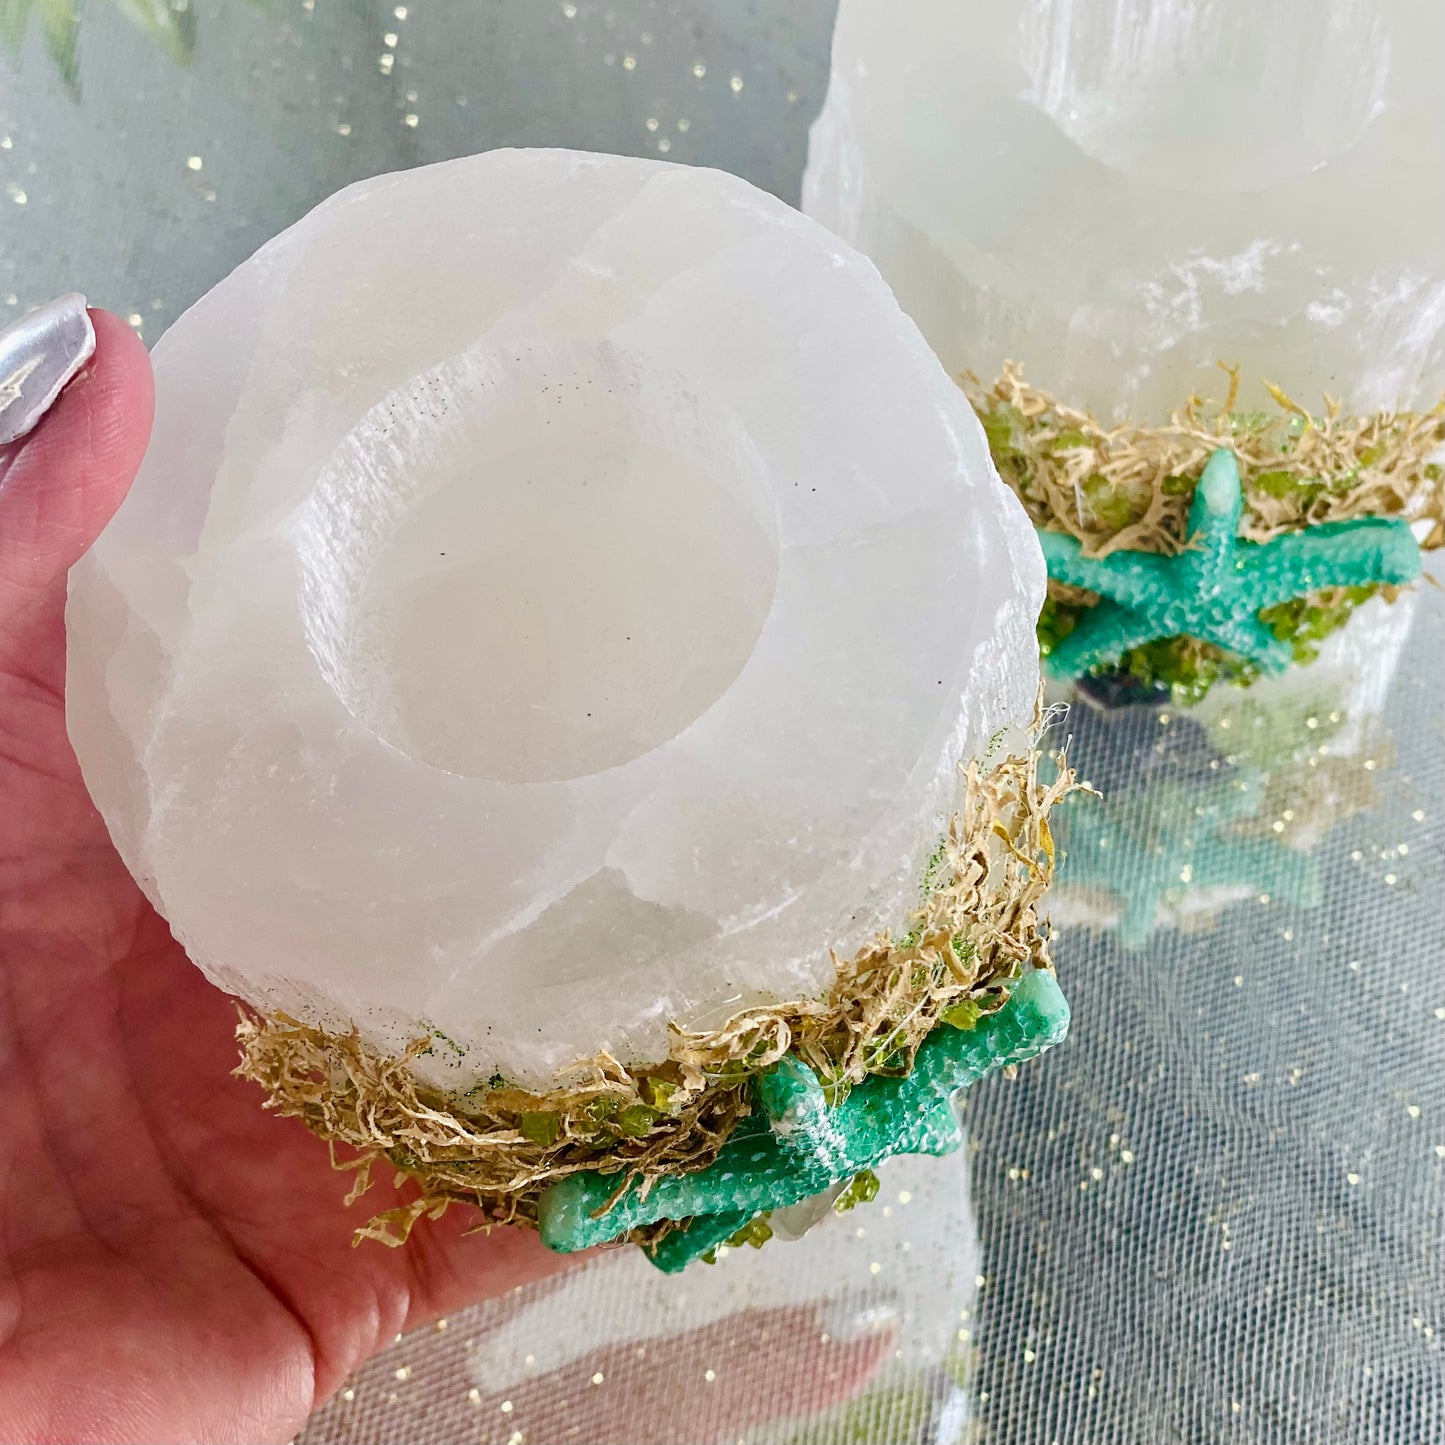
[0,312,559,1442]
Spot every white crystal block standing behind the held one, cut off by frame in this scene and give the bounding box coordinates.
[803,0,1445,422]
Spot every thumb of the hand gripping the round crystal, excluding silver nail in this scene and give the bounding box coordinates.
[0,311,155,627]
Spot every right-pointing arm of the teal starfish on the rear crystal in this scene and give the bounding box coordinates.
[1238,517,1420,607]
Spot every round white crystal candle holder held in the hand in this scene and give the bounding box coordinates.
[68,150,1043,1084]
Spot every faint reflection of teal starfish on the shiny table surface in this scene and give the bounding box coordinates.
[1055,775,1319,952]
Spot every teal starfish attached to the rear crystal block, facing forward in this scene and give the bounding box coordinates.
[1039,448,1420,678]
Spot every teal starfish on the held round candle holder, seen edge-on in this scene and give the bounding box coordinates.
[539,968,1069,1273]
